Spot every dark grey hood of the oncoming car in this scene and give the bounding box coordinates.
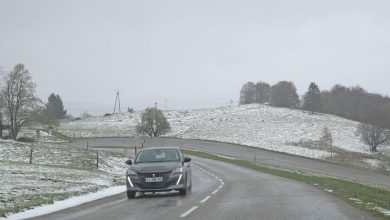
[129,162,182,173]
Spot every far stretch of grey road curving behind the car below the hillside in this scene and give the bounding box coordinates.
[72,138,390,189]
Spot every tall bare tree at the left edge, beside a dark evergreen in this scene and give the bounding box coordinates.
[1,64,39,140]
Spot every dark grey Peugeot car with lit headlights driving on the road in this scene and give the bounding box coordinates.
[126,147,192,199]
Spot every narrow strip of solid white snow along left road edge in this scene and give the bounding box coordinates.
[0,186,126,219]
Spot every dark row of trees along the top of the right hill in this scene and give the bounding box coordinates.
[240,81,390,128]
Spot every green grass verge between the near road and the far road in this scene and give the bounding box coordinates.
[184,149,390,220]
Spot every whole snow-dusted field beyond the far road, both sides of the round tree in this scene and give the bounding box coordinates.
[60,104,390,158]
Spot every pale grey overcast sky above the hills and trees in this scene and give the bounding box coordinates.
[0,0,390,114]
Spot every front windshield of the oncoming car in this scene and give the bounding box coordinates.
[135,149,180,163]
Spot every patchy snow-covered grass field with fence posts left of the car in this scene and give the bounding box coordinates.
[0,140,126,217]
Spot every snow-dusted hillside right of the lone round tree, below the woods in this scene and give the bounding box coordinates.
[168,104,374,156]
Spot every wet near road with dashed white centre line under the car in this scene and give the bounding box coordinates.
[31,157,372,220]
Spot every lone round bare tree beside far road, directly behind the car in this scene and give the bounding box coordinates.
[136,108,171,137]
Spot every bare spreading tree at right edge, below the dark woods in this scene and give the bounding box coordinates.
[356,110,390,152]
